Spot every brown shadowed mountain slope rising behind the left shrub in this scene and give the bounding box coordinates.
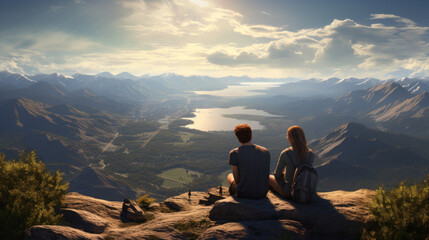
[0,98,119,177]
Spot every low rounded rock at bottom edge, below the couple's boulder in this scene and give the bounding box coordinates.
[198,219,306,240]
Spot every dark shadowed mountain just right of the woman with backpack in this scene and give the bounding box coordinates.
[309,123,429,191]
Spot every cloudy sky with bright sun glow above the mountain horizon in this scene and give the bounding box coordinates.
[0,0,429,79]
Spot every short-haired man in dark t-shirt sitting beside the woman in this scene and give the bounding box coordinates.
[227,124,270,198]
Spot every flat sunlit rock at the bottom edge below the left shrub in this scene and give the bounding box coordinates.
[25,225,104,240]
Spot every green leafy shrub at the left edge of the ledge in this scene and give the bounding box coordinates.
[0,151,68,239]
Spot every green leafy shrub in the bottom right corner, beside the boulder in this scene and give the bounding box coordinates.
[362,175,429,240]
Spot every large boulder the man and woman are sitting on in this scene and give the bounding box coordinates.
[209,189,375,238]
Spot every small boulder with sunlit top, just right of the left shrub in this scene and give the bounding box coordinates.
[61,208,108,233]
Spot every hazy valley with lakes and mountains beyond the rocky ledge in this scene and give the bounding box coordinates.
[0,71,429,200]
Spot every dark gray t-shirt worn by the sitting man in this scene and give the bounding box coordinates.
[229,144,270,198]
